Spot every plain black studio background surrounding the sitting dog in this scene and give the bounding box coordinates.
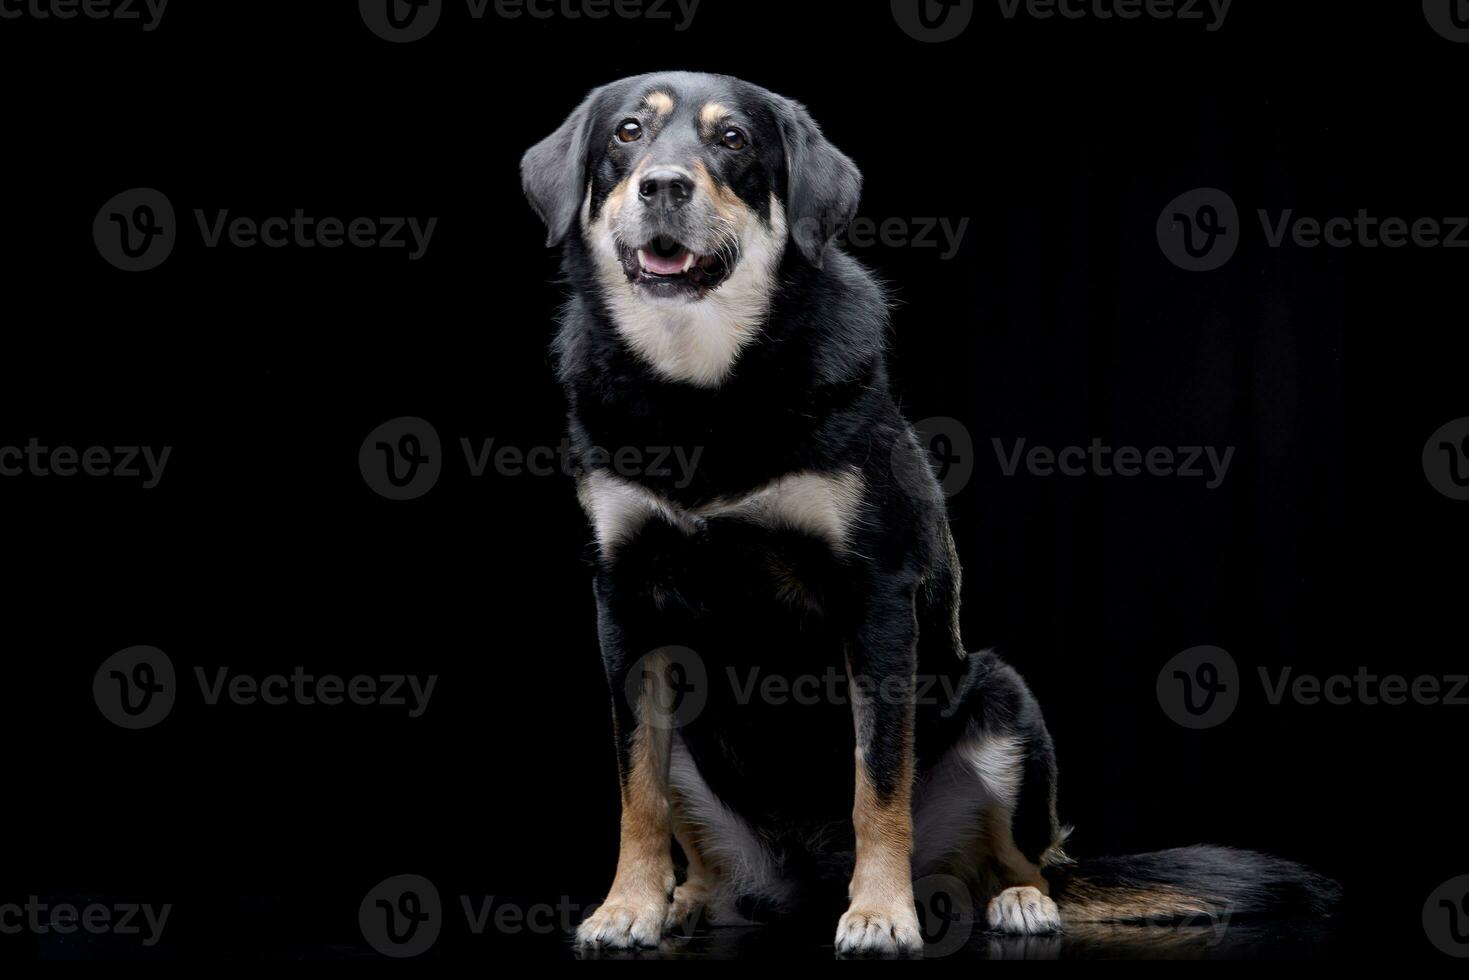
[0,0,1469,959]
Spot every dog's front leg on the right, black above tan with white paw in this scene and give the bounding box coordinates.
[836,586,923,955]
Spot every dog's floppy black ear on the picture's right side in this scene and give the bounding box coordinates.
[780,100,862,269]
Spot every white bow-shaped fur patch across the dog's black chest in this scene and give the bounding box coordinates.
[577,470,862,555]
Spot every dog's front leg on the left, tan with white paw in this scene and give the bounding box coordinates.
[576,608,674,949]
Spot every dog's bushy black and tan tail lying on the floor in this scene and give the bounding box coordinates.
[1047,845,1341,923]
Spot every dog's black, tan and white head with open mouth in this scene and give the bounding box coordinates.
[520,72,862,381]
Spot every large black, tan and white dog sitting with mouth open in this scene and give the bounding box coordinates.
[521,72,1335,955]
